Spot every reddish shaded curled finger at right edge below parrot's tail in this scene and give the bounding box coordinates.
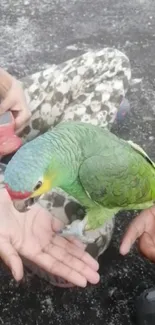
[139,233,155,262]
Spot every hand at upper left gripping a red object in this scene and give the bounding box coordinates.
[0,77,31,133]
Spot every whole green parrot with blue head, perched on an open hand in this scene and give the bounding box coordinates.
[4,121,155,243]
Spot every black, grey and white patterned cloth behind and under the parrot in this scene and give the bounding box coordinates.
[0,48,131,287]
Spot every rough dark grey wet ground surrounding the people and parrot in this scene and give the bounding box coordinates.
[0,0,155,325]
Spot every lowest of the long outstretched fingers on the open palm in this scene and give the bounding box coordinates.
[35,253,98,288]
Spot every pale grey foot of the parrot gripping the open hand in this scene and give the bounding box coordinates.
[59,218,94,244]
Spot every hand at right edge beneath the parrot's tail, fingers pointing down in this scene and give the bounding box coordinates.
[120,206,155,262]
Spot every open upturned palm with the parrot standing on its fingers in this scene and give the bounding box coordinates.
[0,189,99,287]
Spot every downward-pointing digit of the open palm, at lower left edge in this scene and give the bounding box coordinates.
[0,240,23,281]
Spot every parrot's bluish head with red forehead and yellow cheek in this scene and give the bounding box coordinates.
[4,137,68,212]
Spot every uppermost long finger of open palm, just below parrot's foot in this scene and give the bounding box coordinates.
[52,235,99,271]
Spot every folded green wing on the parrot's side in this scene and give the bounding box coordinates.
[79,150,152,209]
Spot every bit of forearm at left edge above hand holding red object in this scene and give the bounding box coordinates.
[0,68,14,99]
